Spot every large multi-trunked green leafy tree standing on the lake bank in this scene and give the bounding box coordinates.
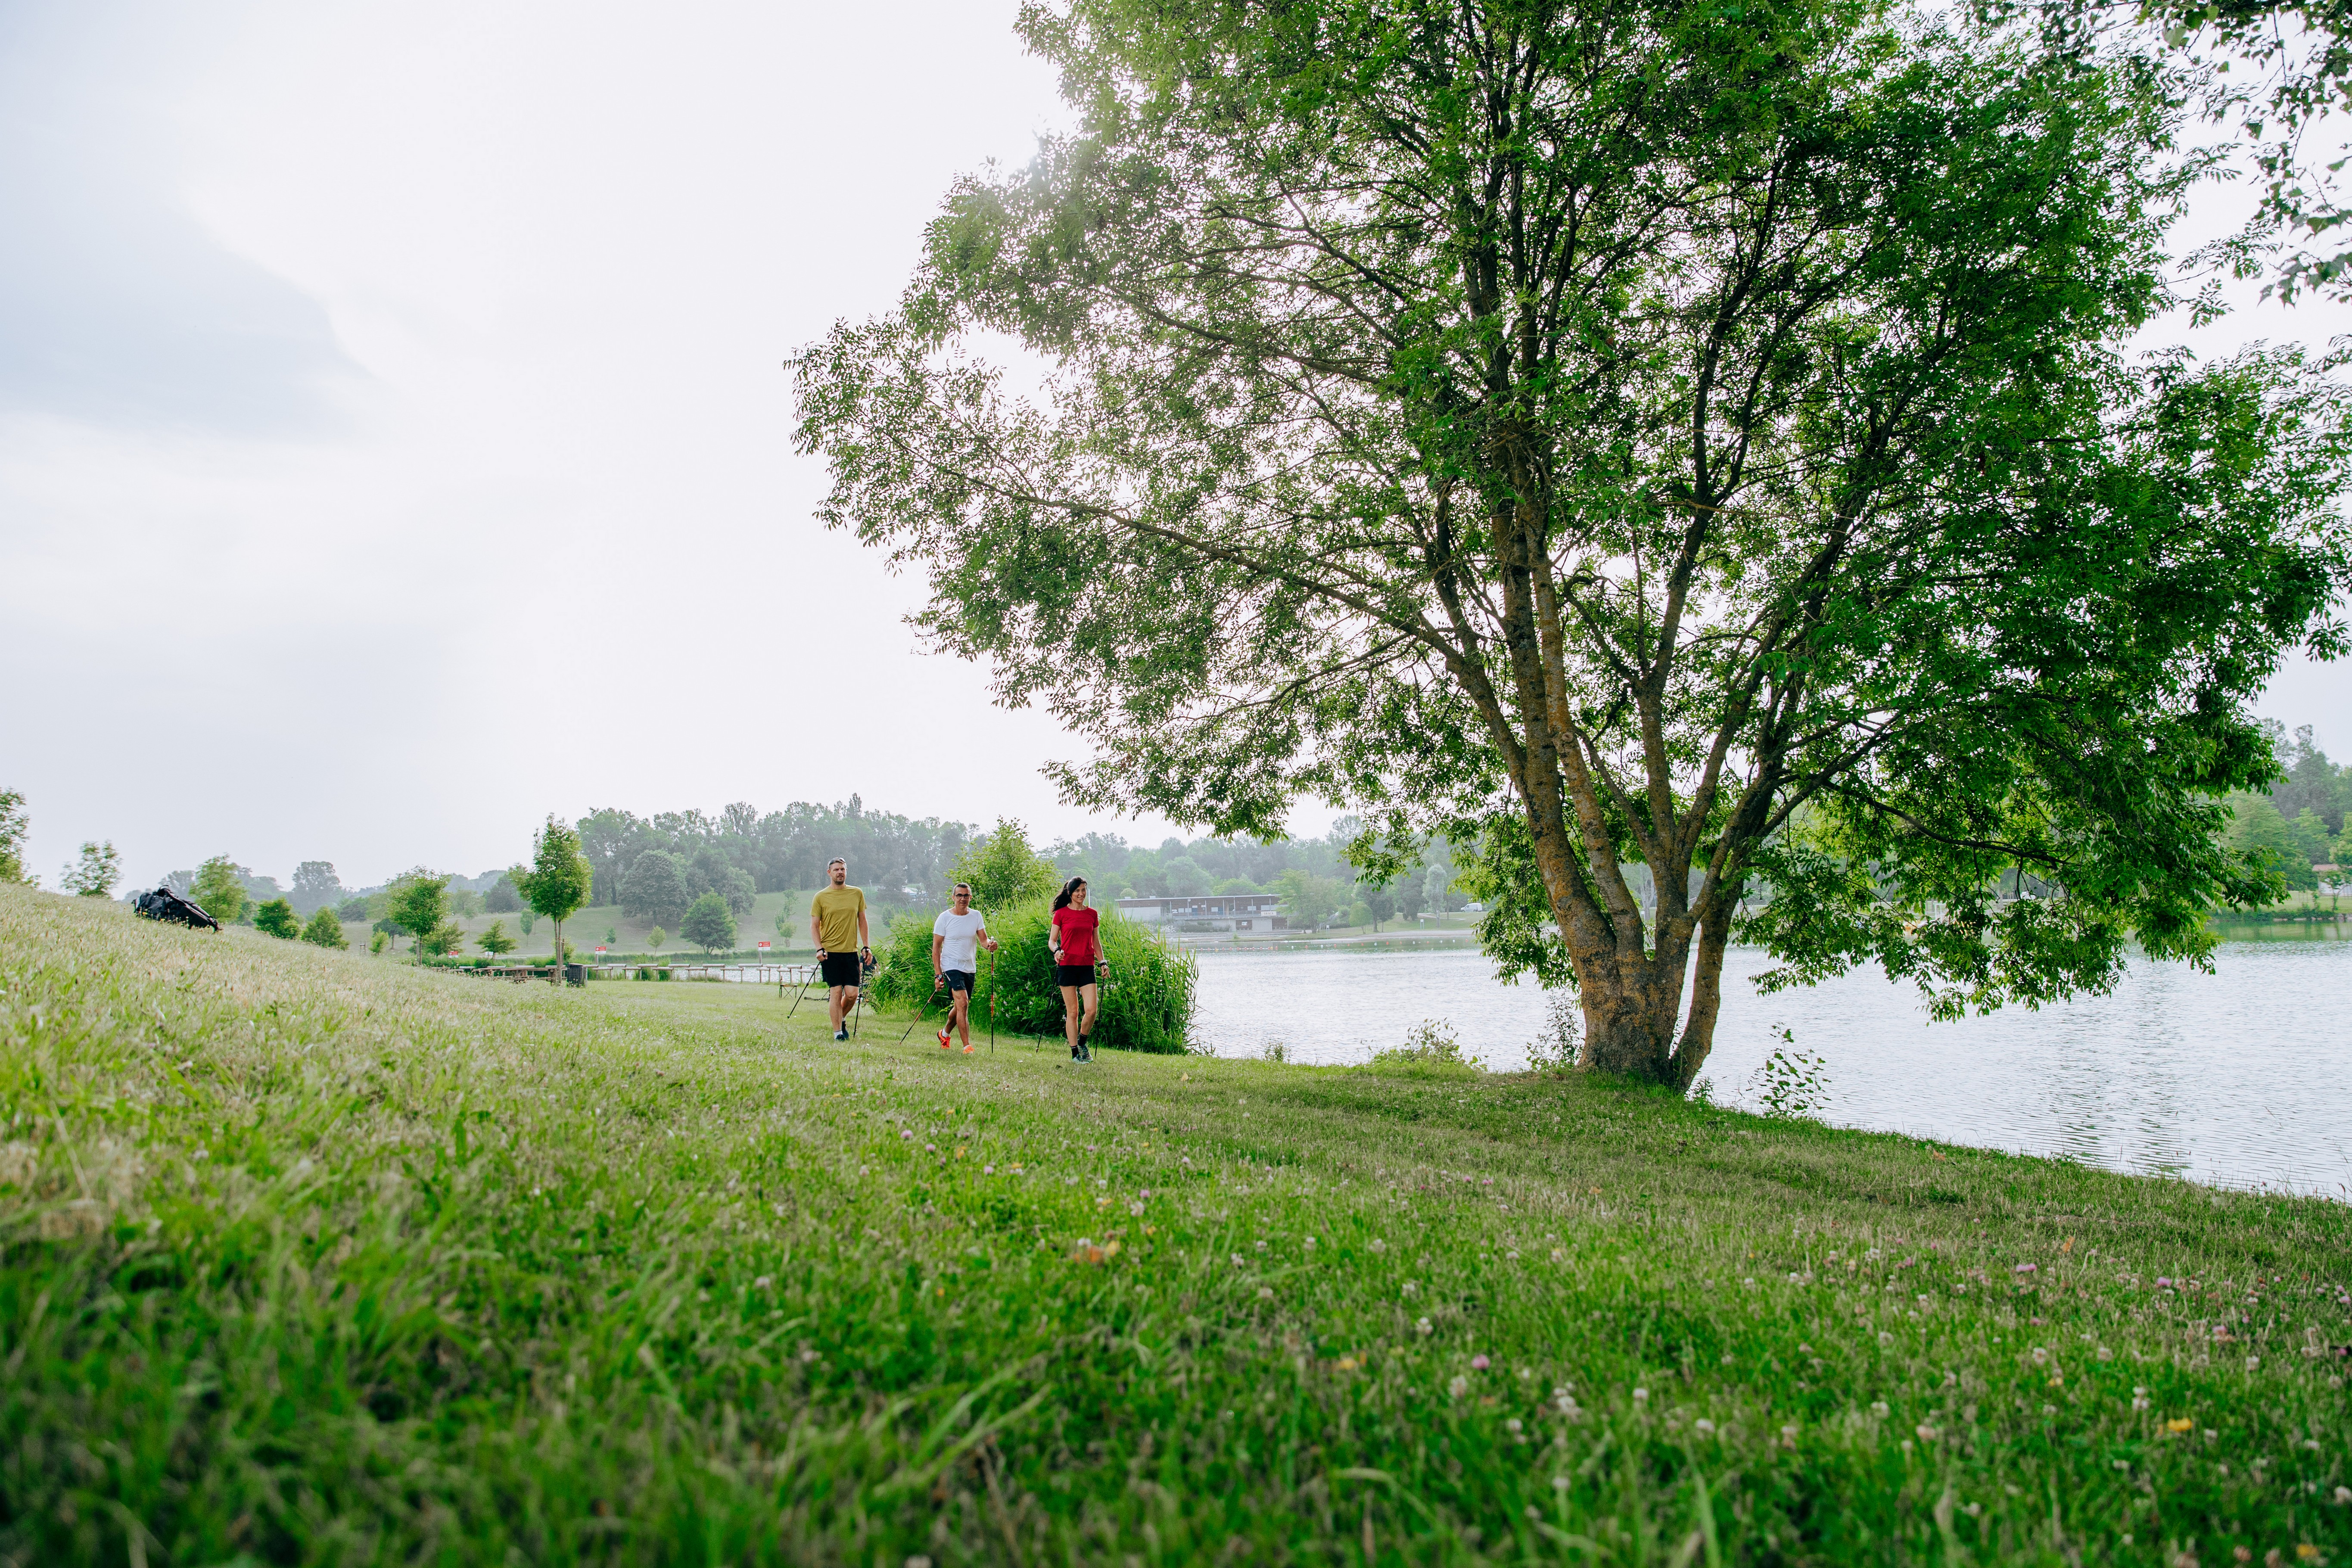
[795,0,2352,1084]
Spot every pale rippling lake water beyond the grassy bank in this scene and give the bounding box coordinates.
[1195,933,2352,1199]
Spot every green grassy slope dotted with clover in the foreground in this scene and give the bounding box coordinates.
[0,889,2352,1568]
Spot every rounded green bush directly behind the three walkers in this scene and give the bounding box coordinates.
[868,903,1200,1053]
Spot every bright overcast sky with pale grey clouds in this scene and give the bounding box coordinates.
[0,0,2352,886]
